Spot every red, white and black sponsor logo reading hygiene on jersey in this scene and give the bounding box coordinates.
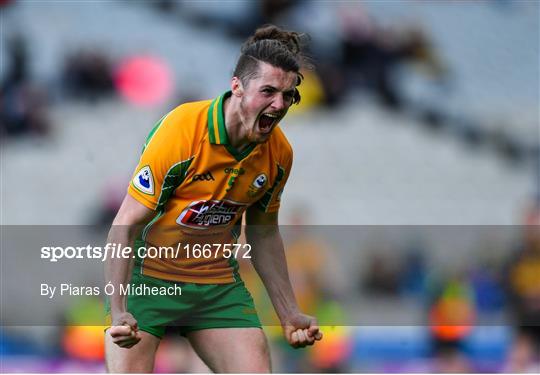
[176,200,244,229]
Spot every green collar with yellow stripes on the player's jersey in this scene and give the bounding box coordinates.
[208,91,256,161]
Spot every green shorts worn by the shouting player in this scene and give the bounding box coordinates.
[106,273,261,338]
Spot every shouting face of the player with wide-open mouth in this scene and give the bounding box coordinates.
[233,62,297,143]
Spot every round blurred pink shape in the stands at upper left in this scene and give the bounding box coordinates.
[114,56,173,106]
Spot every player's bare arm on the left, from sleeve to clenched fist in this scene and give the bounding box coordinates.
[105,194,155,348]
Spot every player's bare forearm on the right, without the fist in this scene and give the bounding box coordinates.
[248,229,299,322]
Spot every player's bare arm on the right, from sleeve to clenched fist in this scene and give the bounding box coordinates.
[246,207,322,347]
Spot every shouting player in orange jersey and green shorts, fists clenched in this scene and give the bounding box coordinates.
[105,26,322,373]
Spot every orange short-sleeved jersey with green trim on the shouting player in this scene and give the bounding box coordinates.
[128,92,292,284]
